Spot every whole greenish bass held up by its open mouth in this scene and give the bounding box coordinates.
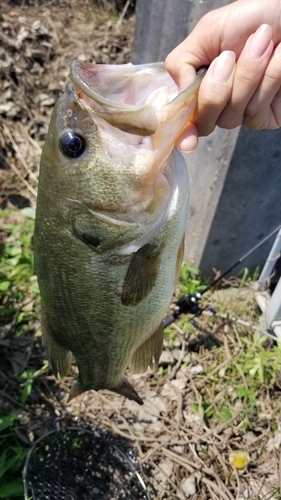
[34,60,206,404]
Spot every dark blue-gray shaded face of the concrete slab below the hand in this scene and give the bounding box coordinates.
[197,127,281,275]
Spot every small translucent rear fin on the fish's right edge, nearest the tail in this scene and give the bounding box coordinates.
[130,323,164,373]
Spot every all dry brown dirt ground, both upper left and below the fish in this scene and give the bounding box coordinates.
[0,0,281,500]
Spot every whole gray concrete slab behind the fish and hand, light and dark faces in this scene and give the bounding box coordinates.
[132,0,281,277]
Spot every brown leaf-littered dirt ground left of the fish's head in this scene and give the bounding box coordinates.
[0,0,134,207]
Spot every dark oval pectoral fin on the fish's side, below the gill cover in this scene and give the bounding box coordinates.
[121,243,162,306]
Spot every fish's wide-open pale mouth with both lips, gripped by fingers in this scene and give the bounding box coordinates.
[70,60,206,142]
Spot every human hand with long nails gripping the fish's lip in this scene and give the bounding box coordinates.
[166,0,281,151]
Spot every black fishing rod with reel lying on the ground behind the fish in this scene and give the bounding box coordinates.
[164,225,281,328]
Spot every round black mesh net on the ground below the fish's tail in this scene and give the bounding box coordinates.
[23,428,150,500]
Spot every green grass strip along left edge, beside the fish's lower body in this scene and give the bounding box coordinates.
[0,210,39,500]
